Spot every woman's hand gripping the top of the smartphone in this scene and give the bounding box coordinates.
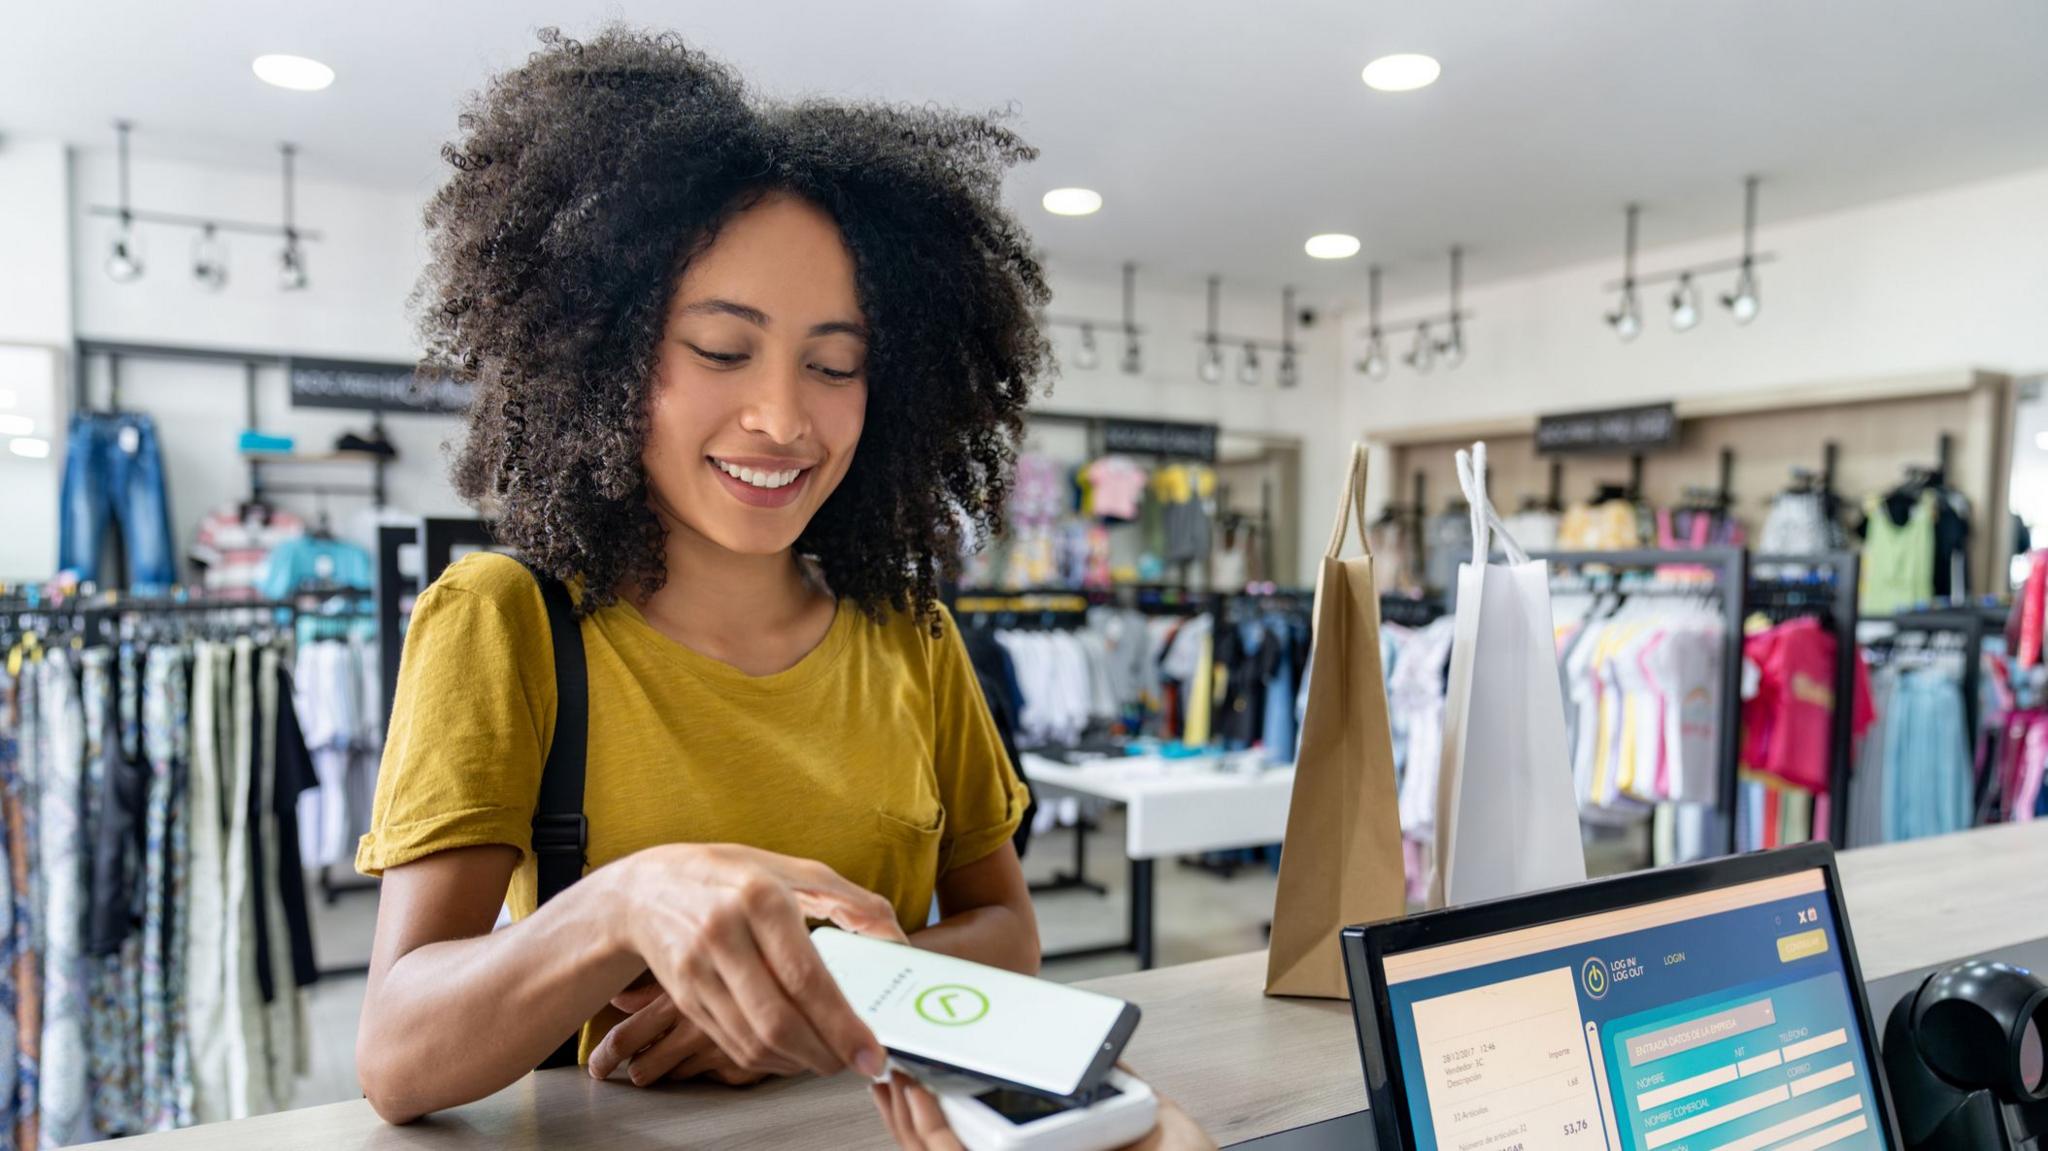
[621,844,901,1079]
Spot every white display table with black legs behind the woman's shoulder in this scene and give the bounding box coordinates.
[1024,752,1294,971]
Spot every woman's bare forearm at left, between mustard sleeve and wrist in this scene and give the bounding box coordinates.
[356,864,645,1122]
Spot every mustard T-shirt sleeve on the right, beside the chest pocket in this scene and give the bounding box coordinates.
[932,608,1030,875]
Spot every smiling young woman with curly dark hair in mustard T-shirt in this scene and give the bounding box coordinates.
[356,31,1212,1141]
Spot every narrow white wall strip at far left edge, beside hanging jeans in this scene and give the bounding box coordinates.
[0,137,72,582]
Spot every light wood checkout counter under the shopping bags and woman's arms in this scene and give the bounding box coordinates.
[123,823,2048,1151]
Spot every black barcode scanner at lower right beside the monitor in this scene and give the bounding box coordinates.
[1884,963,2048,1151]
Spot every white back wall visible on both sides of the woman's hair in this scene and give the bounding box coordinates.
[24,150,1343,578]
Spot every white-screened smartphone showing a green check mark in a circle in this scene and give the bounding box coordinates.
[811,928,1139,1100]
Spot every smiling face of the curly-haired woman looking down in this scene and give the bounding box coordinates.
[641,195,868,555]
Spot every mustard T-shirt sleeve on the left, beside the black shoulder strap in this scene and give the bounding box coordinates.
[356,555,555,875]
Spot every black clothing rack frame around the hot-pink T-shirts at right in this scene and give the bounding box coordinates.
[1743,544,1862,848]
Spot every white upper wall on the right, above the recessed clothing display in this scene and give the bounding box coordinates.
[1343,168,2048,505]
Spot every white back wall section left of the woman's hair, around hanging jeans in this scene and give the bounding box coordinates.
[57,154,467,581]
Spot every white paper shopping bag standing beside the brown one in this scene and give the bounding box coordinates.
[1430,444,1585,907]
